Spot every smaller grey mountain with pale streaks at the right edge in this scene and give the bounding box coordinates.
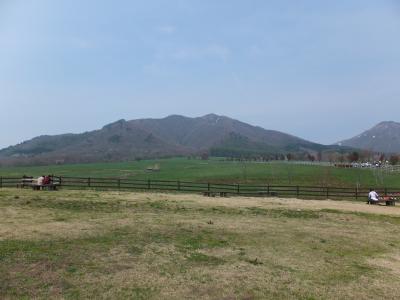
[338,122,400,153]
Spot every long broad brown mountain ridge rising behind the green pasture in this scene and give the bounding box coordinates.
[0,114,346,164]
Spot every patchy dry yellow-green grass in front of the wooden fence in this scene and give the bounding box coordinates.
[0,189,400,299]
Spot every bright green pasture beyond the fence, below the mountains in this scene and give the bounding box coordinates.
[0,158,400,188]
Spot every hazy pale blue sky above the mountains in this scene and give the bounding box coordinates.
[0,0,400,148]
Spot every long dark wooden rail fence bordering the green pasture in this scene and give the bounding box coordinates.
[0,176,400,199]
